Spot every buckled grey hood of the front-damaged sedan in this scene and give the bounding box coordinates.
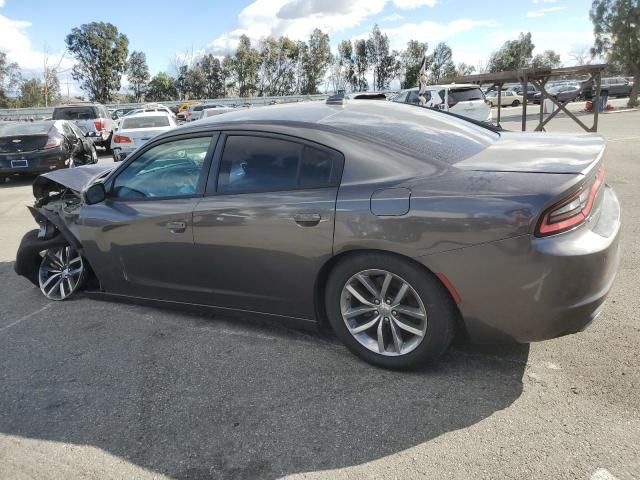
[33,164,116,199]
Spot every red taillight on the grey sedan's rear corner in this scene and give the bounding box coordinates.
[536,167,604,237]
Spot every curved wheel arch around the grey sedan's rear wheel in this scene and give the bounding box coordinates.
[314,248,467,339]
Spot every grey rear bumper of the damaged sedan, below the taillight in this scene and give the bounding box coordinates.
[421,187,621,343]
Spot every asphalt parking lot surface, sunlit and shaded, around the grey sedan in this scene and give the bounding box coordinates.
[0,111,640,479]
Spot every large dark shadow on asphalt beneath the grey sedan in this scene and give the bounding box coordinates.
[0,263,528,479]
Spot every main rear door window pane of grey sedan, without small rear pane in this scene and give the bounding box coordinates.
[218,136,302,192]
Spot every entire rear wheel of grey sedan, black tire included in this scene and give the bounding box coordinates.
[325,253,457,369]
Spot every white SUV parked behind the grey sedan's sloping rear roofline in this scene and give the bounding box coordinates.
[393,83,491,122]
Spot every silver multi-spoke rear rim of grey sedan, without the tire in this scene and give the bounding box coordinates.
[340,269,427,356]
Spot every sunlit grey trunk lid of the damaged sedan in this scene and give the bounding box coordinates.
[455,132,605,174]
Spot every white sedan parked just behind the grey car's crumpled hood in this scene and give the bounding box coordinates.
[111,111,177,162]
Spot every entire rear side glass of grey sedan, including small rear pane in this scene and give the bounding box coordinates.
[218,135,339,193]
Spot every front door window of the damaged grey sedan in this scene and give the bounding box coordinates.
[112,137,211,199]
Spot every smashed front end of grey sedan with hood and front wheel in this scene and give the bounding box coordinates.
[14,165,113,300]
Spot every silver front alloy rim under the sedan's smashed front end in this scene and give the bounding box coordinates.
[38,246,85,300]
